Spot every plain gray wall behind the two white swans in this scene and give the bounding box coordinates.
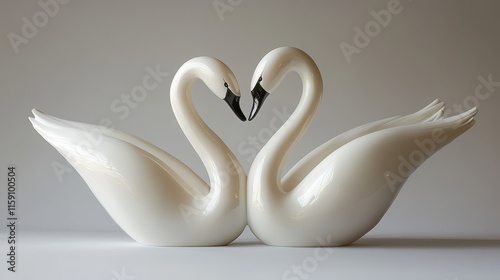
[0,0,500,238]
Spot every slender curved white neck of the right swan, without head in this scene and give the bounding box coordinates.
[252,56,323,195]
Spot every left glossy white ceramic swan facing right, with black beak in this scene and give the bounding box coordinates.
[30,57,246,246]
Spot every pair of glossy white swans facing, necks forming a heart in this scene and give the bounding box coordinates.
[30,47,477,246]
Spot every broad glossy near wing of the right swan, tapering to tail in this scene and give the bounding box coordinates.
[285,108,477,240]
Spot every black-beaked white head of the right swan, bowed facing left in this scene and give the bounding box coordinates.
[248,47,315,120]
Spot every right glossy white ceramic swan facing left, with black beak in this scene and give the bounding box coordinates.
[247,47,477,246]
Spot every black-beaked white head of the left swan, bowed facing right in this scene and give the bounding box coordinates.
[173,56,247,121]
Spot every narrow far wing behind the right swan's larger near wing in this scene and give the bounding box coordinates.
[281,99,444,191]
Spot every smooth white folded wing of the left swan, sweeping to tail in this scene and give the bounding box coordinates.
[30,111,215,240]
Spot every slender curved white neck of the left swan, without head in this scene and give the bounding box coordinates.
[170,68,246,201]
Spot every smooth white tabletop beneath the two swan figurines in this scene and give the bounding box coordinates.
[0,229,500,280]
